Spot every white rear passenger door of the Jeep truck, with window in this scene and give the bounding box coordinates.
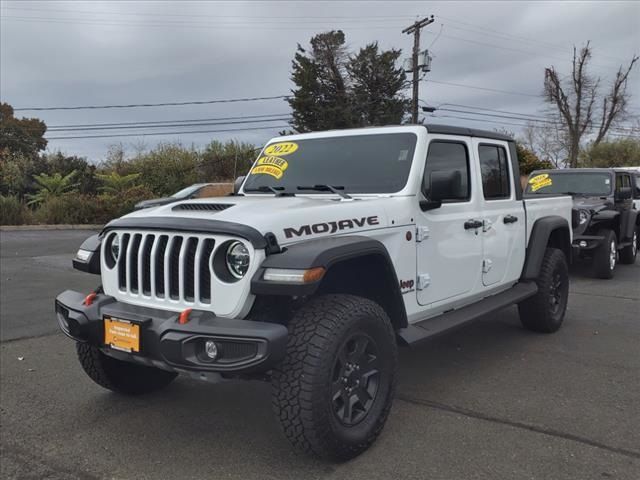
[473,139,526,287]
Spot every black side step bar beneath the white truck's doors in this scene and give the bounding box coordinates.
[398,282,538,345]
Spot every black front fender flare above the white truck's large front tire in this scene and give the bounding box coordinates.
[251,235,407,325]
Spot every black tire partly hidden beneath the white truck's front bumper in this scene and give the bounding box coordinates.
[76,342,177,395]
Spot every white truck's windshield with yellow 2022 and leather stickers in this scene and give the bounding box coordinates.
[244,133,416,194]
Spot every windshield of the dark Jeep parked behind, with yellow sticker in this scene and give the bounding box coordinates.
[526,172,611,197]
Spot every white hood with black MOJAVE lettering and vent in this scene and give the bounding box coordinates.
[123,195,396,245]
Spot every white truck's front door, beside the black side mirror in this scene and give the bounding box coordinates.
[416,136,482,305]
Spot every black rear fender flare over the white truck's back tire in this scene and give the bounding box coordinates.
[521,215,571,280]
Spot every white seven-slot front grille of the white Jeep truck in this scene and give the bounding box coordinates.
[110,232,216,304]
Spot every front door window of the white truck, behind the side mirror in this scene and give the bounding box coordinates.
[422,140,471,202]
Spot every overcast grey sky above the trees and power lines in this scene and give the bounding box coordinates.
[0,0,640,161]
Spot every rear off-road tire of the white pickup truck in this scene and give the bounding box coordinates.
[518,248,569,333]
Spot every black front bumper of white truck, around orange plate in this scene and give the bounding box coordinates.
[55,290,287,374]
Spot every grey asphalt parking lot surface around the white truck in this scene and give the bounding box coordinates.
[0,231,640,480]
